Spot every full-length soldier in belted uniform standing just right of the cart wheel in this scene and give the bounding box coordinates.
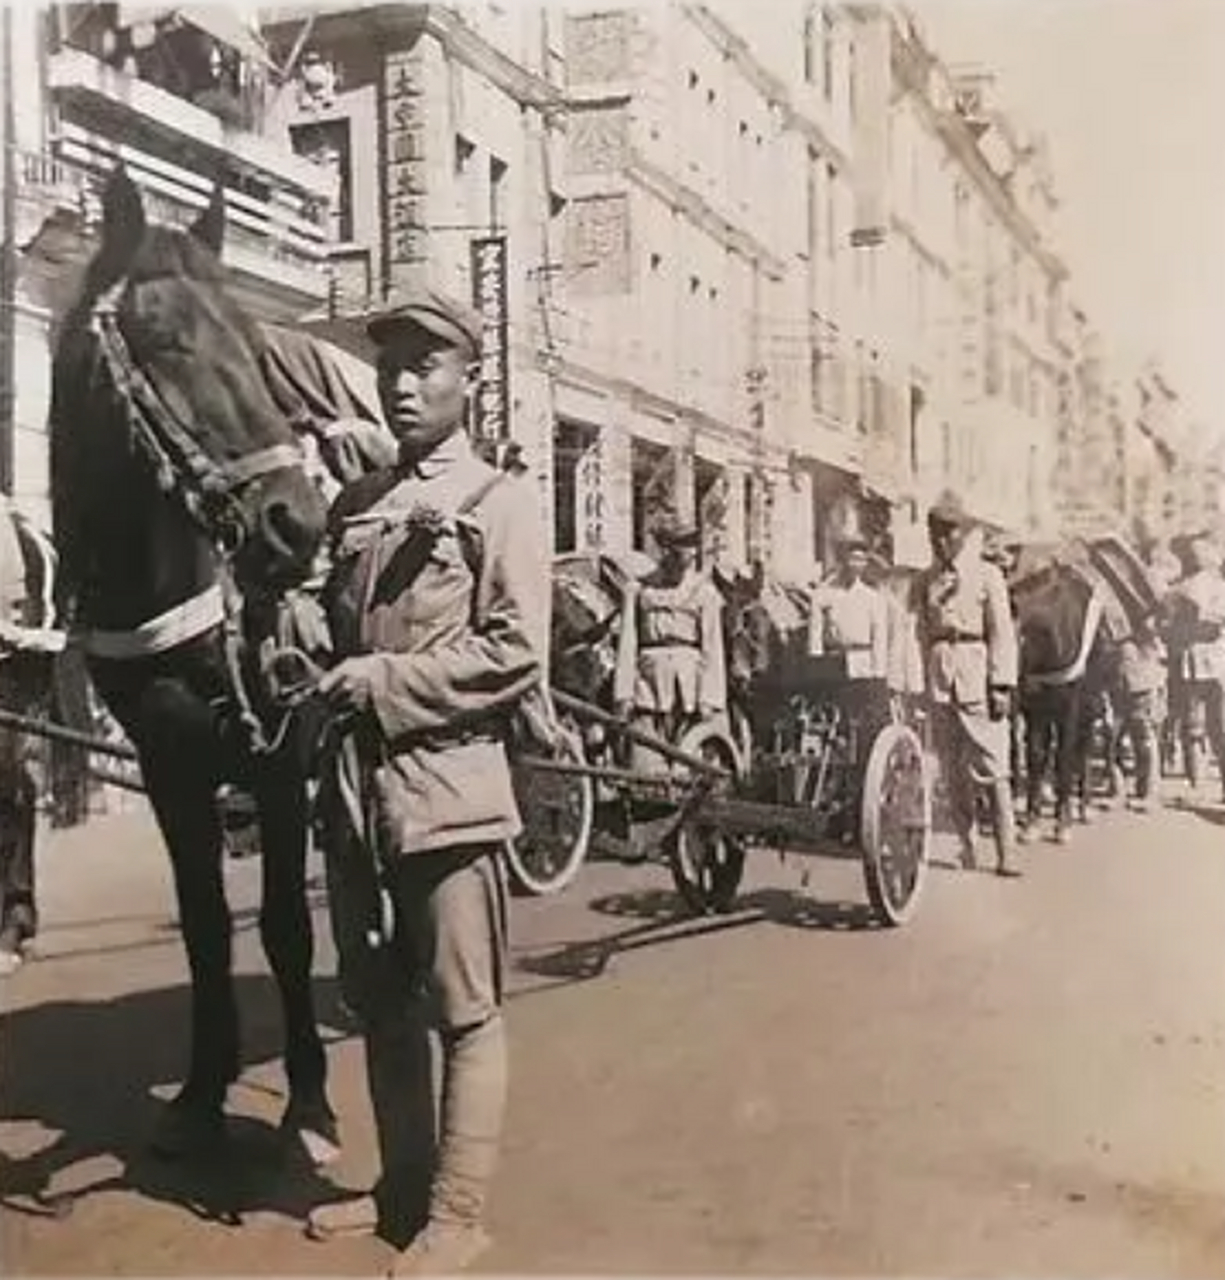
[913,493,1020,876]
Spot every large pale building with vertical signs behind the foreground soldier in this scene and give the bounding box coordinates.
[264,0,890,577]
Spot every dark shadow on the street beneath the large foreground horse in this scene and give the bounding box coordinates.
[0,975,353,1226]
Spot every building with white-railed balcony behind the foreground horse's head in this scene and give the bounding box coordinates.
[0,4,328,518]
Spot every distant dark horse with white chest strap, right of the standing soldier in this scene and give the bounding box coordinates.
[1010,538,1157,841]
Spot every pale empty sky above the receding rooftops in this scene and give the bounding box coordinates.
[910,0,1225,433]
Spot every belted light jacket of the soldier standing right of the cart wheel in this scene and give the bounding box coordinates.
[913,547,1018,707]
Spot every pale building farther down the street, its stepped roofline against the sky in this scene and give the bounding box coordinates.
[853,5,1068,561]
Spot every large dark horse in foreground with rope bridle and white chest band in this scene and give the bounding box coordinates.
[51,169,337,1155]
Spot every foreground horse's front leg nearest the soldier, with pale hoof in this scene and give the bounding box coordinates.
[257,762,339,1164]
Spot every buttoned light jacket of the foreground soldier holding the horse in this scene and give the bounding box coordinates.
[326,431,549,856]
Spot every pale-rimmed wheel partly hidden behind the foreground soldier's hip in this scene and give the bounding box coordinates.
[507,726,595,897]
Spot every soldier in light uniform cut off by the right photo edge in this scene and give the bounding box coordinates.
[1165,531,1225,792]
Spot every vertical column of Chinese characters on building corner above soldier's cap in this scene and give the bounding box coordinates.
[383,51,429,269]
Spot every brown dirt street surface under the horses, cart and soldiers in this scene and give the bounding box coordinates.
[0,788,1225,1276]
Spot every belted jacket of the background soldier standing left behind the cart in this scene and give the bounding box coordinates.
[613,570,727,714]
